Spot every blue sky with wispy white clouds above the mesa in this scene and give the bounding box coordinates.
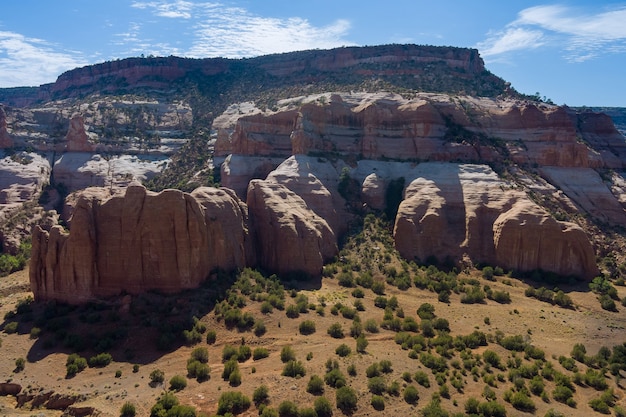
[0,0,626,107]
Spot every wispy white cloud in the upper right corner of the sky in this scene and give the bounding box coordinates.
[476,5,626,62]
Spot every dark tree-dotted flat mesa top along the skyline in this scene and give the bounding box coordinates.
[0,44,498,107]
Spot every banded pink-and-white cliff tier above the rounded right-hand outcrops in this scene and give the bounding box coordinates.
[213,93,626,168]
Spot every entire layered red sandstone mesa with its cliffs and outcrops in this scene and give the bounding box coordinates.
[0,45,626,303]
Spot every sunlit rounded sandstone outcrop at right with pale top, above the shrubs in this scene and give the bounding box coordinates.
[394,163,598,278]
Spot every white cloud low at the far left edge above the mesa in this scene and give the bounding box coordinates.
[0,31,87,87]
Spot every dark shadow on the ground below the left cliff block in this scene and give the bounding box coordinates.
[0,272,266,365]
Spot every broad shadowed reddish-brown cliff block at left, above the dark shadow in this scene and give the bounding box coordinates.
[30,185,254,303]
